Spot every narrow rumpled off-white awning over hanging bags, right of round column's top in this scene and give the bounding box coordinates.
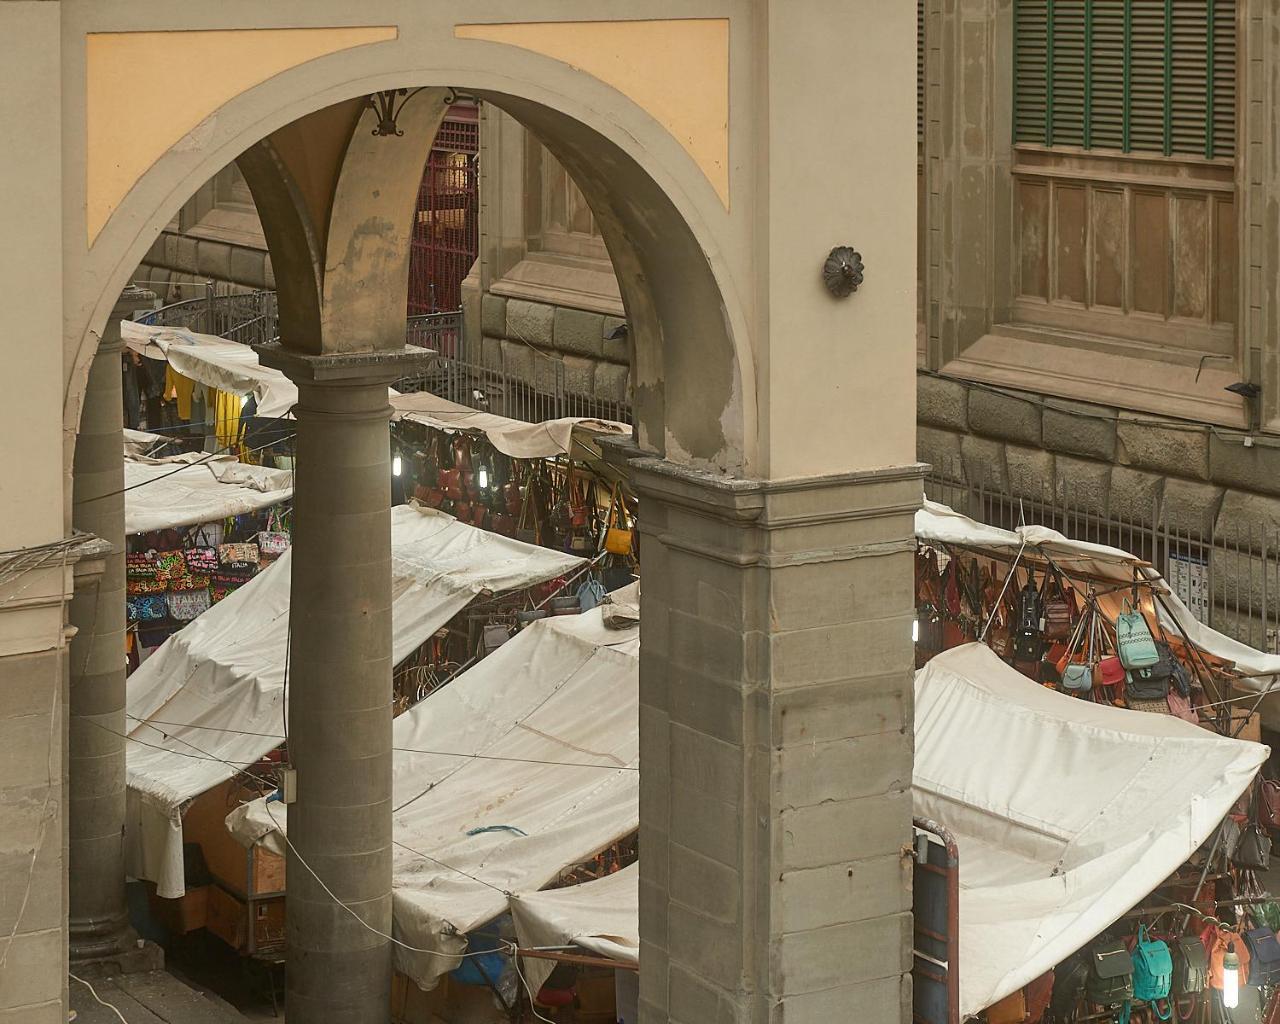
[392,392,631,458]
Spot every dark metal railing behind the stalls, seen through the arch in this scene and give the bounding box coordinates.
[138,285,631,422]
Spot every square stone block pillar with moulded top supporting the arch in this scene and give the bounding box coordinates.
[632,460,922,1024]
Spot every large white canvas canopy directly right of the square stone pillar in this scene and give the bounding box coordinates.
[914,644,1267,1016]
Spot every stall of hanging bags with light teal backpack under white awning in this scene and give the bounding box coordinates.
[916,502,1280,739]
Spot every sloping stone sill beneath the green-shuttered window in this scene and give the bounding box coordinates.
[942,324,1248,429]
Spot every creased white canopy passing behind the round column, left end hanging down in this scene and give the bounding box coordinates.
[125,506,582,897]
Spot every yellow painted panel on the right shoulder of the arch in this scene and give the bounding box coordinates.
[453,18,728,210]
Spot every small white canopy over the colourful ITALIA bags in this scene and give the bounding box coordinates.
[124,452,293,534]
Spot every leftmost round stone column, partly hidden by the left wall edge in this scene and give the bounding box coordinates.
[67,287,155,960]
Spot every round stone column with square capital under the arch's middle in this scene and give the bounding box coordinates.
[259,346,420,1024]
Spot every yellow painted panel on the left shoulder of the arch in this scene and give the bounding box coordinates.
[84,26,398,244]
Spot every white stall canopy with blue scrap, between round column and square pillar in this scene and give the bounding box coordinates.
[228,588,640,988]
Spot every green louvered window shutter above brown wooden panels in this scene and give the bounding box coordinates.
[1014,0,1236,159]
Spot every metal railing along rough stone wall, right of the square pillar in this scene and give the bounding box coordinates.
[924,465,1280,654]
